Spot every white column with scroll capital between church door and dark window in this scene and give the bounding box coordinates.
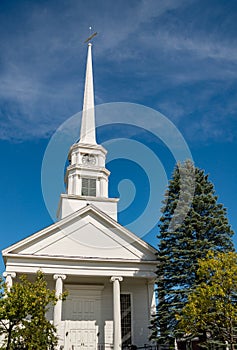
[110,276,123,350]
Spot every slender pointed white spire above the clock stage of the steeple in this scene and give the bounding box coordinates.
[79,43,96,145]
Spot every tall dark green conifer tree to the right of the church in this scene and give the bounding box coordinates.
[151,160,234,344]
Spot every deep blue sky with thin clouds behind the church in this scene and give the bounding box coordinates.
[0,0,237,269]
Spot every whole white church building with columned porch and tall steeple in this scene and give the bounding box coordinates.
[2,43,156,350]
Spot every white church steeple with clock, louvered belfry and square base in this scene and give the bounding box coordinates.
[58,43,118,220]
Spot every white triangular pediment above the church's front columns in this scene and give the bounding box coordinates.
[3,205,155,260]
